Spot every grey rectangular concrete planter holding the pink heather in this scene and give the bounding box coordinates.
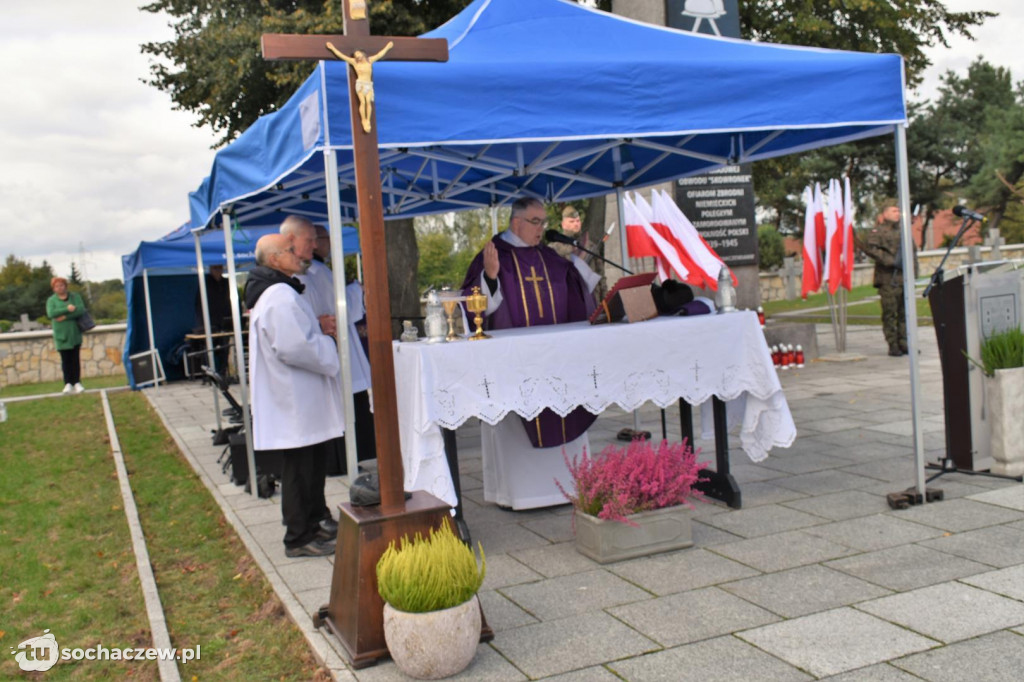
[575,506,693,563]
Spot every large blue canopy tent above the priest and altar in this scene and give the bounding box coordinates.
[184,0,924,496]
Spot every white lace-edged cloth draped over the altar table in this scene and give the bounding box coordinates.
[393,311,797,505]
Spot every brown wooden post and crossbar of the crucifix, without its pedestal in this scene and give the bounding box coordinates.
[262,0,447,508]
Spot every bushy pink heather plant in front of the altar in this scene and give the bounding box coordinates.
[555,439,706,525]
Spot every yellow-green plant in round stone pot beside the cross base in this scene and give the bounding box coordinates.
[377,522,487,680]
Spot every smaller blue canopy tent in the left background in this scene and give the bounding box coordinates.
[121,223,359,388]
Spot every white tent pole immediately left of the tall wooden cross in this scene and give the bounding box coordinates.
[324,148,359,485]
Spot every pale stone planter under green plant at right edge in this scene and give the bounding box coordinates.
[985,368,1024,476]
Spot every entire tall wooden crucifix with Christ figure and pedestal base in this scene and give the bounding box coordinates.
[262,0,464,668]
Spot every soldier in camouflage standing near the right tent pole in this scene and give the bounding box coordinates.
[857,199,918,355]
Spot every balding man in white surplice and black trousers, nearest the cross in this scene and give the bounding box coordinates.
[245,235,345,557]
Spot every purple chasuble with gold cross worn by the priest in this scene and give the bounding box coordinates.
[462,236,597,447]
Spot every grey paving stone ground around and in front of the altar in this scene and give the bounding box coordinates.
[146,327,1024,682]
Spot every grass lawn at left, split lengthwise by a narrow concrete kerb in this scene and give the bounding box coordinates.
[0,393,327,681]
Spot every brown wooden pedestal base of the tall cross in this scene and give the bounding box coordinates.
[313,492,494,670]
